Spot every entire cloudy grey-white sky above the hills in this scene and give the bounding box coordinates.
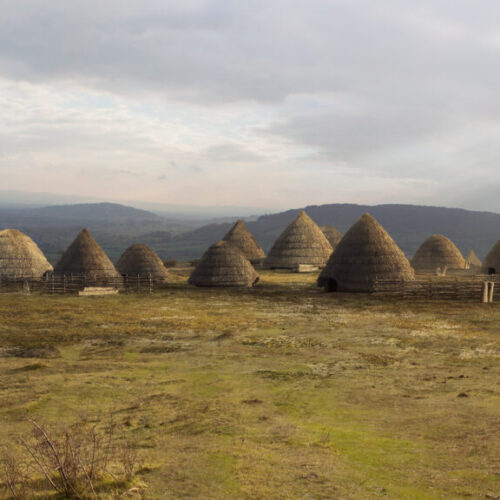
[0,0,500,211]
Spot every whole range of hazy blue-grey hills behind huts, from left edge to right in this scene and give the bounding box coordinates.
[0,203,500,263]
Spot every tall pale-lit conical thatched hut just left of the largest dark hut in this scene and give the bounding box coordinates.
[265,210,333,269]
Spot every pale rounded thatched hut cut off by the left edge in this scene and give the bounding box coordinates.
[0,229,52,278]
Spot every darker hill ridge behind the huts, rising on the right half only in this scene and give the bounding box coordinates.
[165,203,500,259]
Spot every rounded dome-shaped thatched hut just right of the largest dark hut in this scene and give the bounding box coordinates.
[411,234,466,271]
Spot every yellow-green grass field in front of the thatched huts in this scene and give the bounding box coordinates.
[0,272,500,499]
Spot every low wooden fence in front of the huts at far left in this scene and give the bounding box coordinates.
[0,275,158,294]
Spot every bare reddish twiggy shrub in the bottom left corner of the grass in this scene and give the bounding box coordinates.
[0,419,138,499]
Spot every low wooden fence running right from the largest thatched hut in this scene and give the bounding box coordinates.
[373,275,500,302]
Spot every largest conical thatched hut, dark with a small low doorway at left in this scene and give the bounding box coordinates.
[318,214,415,292]
